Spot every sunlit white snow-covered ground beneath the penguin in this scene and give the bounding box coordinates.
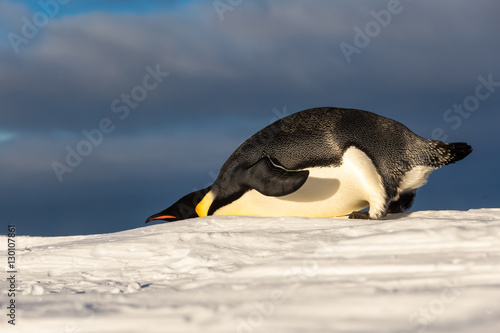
[0,209,500,333]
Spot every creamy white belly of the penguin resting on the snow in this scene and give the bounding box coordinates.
[214,147,385,217]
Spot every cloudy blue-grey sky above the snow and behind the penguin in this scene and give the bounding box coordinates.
[0,0,500,236]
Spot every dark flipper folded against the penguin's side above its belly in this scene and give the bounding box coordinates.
[242,156,309,197]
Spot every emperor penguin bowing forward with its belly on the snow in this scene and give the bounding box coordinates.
[146,107,472,222]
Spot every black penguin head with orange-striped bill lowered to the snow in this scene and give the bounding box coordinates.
[146,187,210,223]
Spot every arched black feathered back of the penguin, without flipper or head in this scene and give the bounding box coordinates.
[214,107,440,206]
